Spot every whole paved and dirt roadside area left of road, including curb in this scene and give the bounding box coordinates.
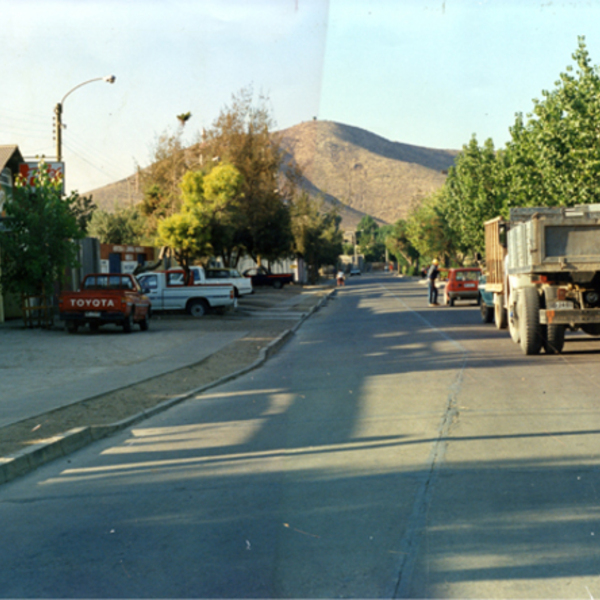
[0,285,335,484]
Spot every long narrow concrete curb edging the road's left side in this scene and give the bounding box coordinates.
[0,288,337,485]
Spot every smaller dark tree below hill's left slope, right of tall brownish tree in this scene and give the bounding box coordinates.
[292,192,344,284]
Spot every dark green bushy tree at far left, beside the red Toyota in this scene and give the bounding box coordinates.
[0,163,83,314]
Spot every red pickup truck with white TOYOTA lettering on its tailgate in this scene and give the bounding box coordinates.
[58,273,151,333]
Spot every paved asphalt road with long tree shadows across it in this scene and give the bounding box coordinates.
[0,276,600,598]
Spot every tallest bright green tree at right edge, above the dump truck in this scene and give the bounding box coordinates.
[505,37,600,208]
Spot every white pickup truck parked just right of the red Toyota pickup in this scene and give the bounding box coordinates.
[138,269,237,317]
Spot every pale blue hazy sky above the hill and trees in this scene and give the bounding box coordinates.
[0,0,600,192]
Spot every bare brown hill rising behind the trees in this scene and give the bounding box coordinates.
[86,120,458,229]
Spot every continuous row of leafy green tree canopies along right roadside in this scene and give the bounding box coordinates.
[400,37,600,262]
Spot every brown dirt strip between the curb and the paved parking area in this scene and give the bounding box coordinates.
[0,289,327,456]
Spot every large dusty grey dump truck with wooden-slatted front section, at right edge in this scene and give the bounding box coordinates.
[485,204,600,354]
